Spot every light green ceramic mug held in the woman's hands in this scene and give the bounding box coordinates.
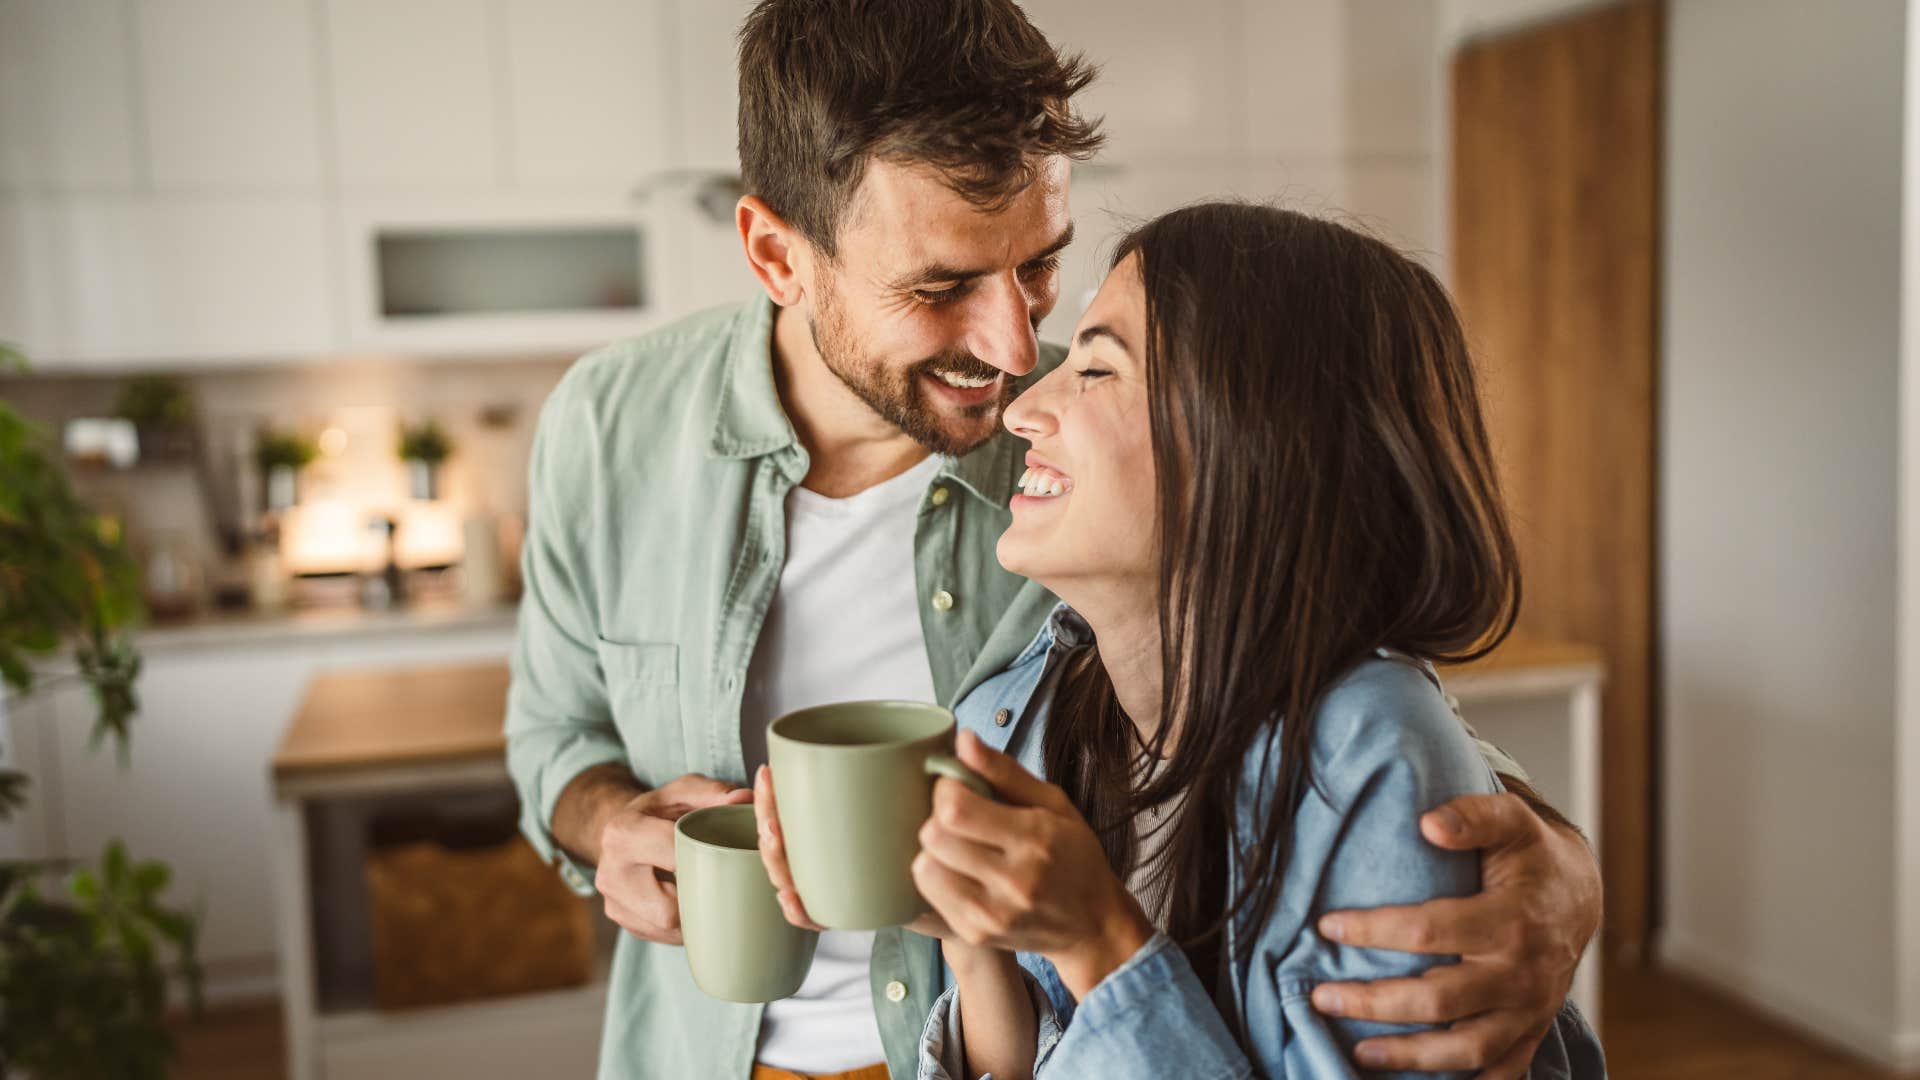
[766,701,993,930]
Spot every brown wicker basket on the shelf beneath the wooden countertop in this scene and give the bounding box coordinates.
[367,836,593,1009]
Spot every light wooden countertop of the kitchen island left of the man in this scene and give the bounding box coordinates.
[273,661,507,780]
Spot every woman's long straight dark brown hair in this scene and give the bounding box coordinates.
[1044,202,1521,984]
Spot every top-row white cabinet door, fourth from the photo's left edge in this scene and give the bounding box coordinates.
[503,0,672,186]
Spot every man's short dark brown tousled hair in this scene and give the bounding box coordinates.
[739,0,1102,256]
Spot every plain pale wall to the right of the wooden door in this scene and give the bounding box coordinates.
[1659,0,1912,1059]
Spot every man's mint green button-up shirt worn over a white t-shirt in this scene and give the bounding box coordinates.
[507,298,1064,1080]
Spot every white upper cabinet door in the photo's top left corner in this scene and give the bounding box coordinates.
[0,0,142,190]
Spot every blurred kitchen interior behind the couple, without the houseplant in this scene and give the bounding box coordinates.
[0,0,1920,1080]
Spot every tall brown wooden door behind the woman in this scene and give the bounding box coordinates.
[1452,2,1663,957]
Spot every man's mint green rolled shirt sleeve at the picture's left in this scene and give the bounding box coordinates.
[505,368,628,896]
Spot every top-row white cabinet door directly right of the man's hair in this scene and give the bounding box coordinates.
[1021,0,1260,163]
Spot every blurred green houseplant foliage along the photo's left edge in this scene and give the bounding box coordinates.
[0,346,200,1080]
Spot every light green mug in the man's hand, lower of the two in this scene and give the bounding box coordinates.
[674,803,820,1001]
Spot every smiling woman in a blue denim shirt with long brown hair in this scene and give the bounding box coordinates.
[764,204,1605,1080]
